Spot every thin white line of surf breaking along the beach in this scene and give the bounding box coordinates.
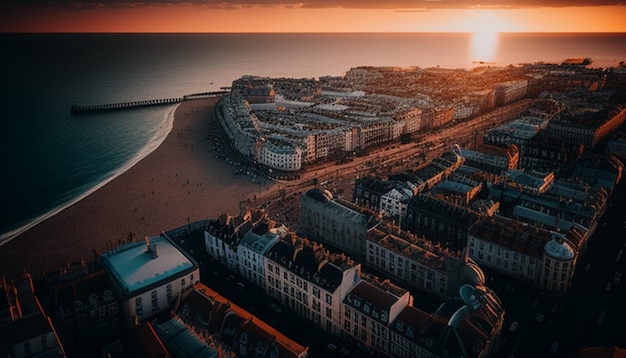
[0,103,180,246]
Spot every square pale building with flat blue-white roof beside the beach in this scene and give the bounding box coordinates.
[100,234,200,326]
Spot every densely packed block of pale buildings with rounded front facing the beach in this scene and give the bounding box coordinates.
[218,69,527,172]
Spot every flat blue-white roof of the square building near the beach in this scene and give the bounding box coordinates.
[101,236,197,294]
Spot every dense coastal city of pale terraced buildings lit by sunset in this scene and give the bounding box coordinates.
[0,58,626,358]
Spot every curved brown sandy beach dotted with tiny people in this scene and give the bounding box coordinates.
[0,98,271,278]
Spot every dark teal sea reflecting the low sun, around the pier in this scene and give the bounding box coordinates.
[0,33,626,249]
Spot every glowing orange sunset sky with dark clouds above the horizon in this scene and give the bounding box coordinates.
[0,0,626,33]
